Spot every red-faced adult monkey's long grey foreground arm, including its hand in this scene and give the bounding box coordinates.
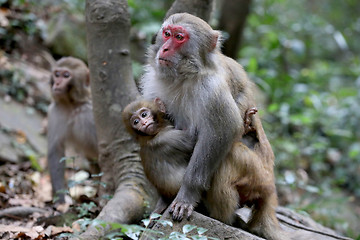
[170,91,243,221]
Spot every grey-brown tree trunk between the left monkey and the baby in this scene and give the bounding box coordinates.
[83,0,156,239]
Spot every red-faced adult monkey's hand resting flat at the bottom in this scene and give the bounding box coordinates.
[169,188,197,221]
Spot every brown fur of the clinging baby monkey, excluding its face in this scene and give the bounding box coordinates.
[122,101,194,202]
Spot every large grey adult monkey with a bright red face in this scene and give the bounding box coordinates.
[142,13,281,239]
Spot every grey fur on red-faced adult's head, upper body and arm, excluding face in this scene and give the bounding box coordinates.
[141,14,252,212]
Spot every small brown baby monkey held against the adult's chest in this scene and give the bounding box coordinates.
[122,98,195,204]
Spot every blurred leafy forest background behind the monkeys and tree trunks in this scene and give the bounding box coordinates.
[0,0,360,238]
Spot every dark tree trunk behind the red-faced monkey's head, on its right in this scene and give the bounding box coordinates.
[219,0,251,59]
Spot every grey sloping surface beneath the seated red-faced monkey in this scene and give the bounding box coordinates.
[140,207,351,240]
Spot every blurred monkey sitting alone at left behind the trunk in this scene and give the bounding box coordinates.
[47,57,98,203]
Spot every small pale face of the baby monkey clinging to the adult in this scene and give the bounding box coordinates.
[130,107,156,135]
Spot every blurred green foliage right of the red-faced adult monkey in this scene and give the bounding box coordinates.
[240,0,360,197]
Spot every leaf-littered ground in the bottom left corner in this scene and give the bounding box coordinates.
[0,158,99,240]
